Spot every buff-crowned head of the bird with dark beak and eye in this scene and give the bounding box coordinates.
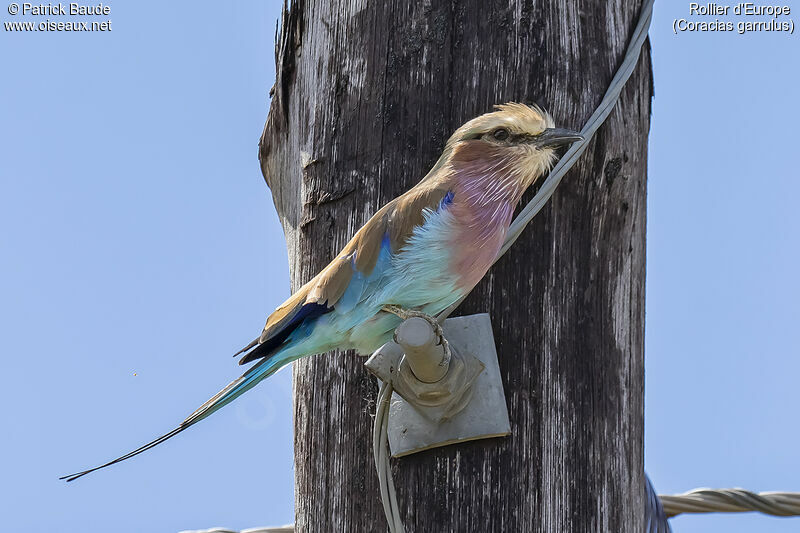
[437,103,583,194]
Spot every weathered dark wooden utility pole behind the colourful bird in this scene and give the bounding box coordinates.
[259,0,652,533]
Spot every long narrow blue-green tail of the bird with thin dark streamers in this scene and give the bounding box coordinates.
[59,352,297,481]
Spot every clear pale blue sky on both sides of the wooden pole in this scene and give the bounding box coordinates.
[0,1,800,533]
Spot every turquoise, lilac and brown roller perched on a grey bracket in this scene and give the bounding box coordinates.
[62,103,582,481]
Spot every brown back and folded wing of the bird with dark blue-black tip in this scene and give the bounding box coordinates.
[236,180,452,364]
